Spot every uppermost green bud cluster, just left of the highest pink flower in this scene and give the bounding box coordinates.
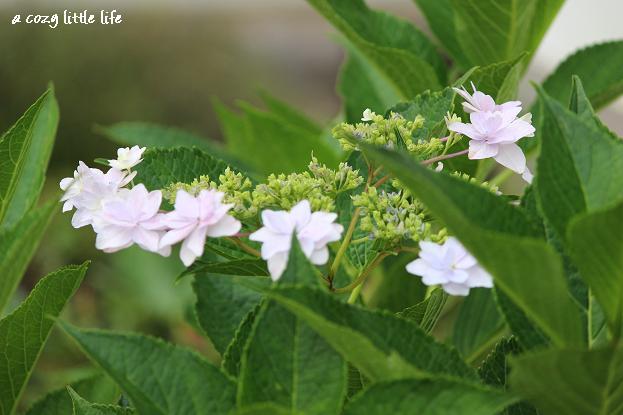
[333,109,432,153]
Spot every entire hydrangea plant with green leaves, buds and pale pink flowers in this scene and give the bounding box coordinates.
[0,0,623,415]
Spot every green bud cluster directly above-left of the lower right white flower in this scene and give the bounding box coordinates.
[352,186,438,243]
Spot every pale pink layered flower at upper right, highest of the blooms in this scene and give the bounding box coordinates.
[448,84,535,182]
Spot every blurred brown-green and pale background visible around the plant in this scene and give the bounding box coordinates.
[0,0,623,410]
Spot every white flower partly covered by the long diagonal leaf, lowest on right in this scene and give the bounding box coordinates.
[407,237,493,295]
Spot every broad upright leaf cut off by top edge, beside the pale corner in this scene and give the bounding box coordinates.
[446,0,564,66]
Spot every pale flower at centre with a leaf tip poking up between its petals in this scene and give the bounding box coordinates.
[249,200,344,281]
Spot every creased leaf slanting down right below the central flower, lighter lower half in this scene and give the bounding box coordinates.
[241,287,476,381]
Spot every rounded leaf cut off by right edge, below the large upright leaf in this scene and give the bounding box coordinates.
[567,203,623,335]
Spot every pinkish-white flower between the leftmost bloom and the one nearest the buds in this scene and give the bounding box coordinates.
[93,184,171,256]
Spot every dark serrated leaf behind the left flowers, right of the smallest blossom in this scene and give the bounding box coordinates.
[136,147,232,190]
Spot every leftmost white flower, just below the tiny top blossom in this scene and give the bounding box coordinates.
[60,162,136,228]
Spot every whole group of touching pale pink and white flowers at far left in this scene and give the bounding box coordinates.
[60,146,240,266]
